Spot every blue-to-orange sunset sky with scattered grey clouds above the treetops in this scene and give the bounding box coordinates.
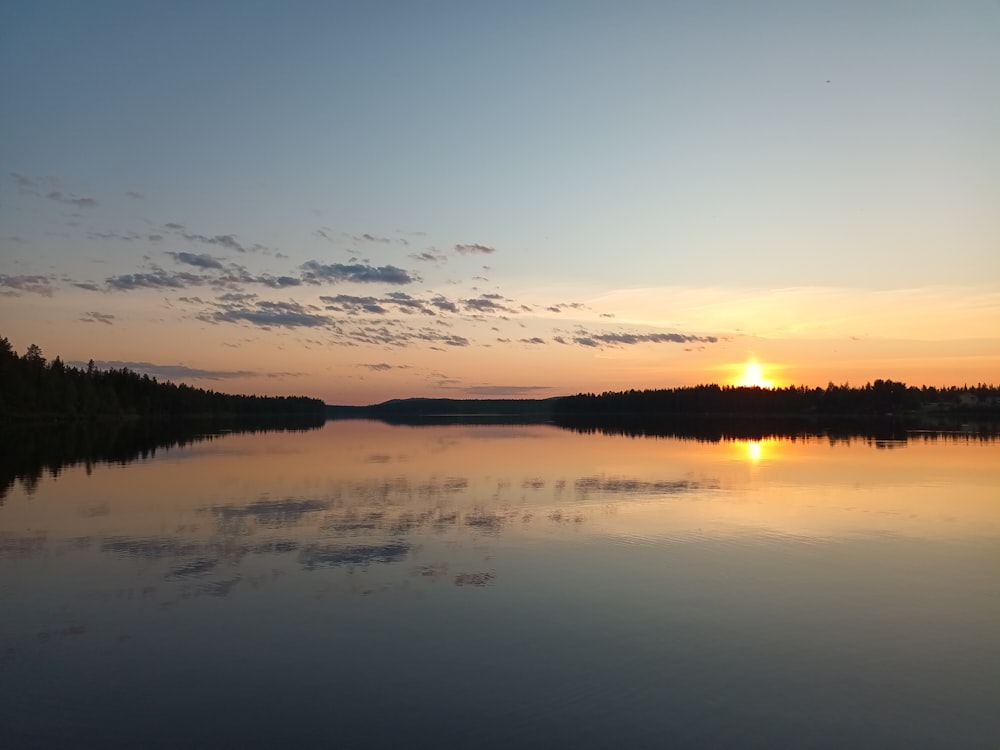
[0,0,1000,404]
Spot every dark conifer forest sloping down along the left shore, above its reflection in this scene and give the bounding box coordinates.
[0,337,325,422]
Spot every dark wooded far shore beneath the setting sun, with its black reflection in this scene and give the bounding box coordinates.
[326,388,1000,436]
